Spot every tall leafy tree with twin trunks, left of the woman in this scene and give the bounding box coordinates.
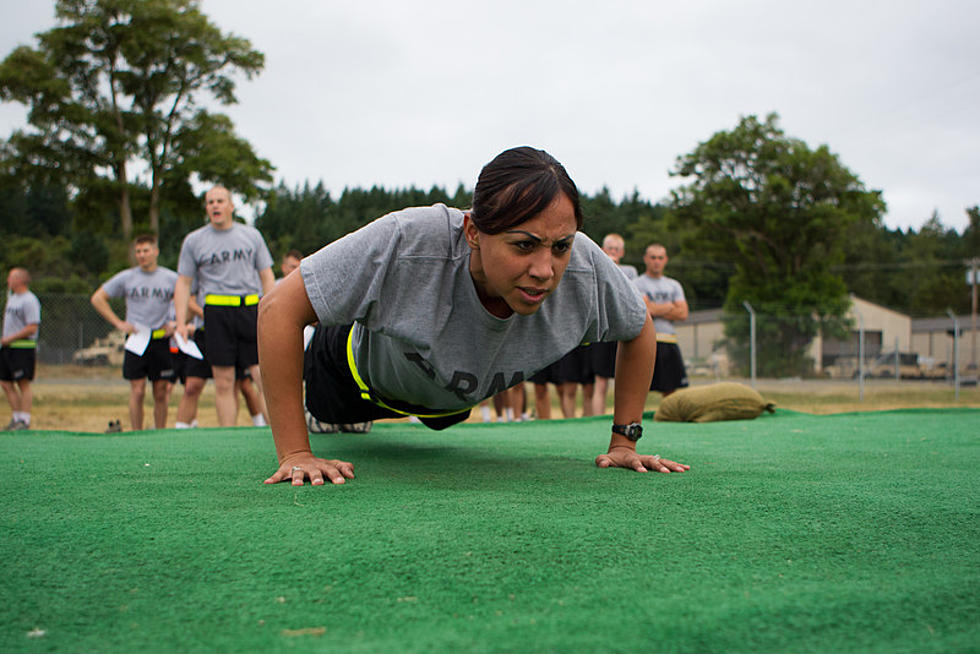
[0,0,271,241]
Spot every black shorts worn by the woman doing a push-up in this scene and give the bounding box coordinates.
[305,325,470,430]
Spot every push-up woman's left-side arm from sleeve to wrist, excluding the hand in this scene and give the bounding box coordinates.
[258,291,311,463]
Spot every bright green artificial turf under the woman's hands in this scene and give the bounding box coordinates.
[0,410,980,652]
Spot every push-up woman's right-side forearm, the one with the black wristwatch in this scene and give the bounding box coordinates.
[609,316,657,448]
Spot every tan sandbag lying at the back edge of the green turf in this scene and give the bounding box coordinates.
[653,382,775,422]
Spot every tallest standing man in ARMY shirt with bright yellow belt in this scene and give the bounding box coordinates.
[174,186,275,427]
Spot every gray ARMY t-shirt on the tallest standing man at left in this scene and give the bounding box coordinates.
[177,223,273,295]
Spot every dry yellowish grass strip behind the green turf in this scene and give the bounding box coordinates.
[21,366,980,432]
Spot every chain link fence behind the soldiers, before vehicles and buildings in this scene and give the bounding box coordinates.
[4,293,978,392]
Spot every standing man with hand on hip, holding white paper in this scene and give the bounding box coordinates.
[92,235,177,431]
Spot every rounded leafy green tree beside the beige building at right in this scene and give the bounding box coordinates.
[671,114,884,375]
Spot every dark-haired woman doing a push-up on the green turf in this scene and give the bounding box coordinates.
[259,147,687,485]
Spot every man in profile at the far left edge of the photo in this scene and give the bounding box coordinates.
[0,268,41,430]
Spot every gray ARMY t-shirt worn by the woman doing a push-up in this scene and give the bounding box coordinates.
[300,204,646,411]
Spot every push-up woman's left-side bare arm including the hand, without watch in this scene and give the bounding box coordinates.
[258,275,354,485]
